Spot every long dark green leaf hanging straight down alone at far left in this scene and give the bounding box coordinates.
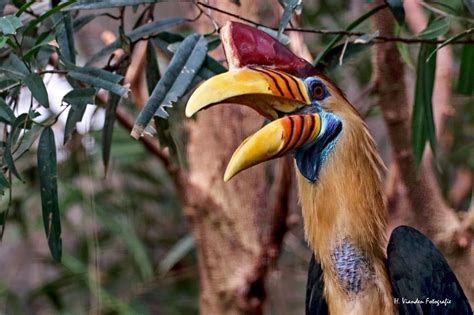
[38,127,62,262]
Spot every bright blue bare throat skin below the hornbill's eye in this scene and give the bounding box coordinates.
[294,111,342,183]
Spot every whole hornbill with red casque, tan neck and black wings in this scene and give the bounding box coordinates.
[186,22,472,315]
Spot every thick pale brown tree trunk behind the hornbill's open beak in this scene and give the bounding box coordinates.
[180,1,290,314]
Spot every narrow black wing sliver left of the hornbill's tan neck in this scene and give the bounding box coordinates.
[306,254,328,315]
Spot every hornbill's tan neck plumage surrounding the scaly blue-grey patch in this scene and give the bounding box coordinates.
[297,111,393,314]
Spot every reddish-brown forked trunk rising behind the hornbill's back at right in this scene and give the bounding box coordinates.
[372,0,474,301]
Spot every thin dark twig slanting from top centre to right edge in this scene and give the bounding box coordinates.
[196,1,474,45]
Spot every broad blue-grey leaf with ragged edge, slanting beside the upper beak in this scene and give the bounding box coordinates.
[132,34,207,139]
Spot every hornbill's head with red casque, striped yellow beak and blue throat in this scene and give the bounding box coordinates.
[186,22,353,182]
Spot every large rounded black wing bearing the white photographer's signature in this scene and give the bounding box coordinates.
[387,226,472,315]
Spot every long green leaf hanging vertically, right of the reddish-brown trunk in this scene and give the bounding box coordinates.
[412,44,436,165]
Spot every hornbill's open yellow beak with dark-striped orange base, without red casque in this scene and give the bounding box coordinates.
[186,67,321,181]
